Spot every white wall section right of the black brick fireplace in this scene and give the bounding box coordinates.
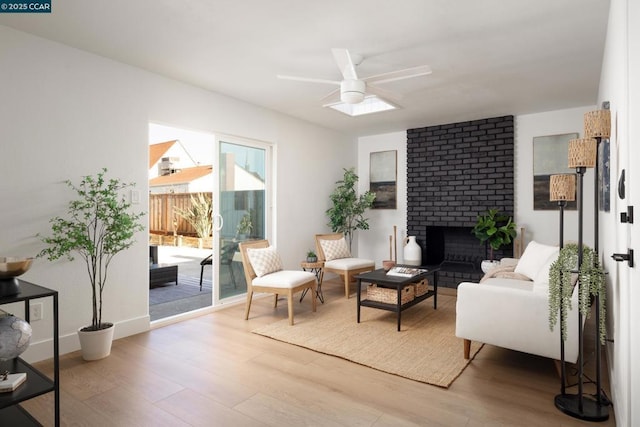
[514,106,596,246]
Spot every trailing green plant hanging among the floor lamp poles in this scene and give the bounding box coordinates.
[549,243,607,344]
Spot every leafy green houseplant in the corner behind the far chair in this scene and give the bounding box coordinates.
[326,168,376,254]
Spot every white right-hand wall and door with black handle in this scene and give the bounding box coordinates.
[598,0,640,426]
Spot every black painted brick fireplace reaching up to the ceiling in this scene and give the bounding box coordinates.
[407,116,514,288]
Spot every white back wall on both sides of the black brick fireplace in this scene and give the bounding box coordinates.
[357,106,595,265]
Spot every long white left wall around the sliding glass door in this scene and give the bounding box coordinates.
[0,26,356,360]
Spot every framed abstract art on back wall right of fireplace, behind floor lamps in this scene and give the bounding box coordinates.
[533,133,578,210]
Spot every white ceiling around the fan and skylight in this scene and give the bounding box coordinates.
[0,0,609,135]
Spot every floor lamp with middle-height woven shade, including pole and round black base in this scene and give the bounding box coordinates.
[554,138,609,421]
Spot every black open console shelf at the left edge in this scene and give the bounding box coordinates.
[0,280,60,427]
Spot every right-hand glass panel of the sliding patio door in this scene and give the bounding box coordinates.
[214,137,271,304]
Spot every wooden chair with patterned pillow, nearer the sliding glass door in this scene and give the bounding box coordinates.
[240,240,317,325]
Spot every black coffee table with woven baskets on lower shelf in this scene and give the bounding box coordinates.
[355,266,440,331]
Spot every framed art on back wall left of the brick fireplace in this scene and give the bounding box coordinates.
[369,150,398,209]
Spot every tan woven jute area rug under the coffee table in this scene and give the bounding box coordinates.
[253,295,482,388]
